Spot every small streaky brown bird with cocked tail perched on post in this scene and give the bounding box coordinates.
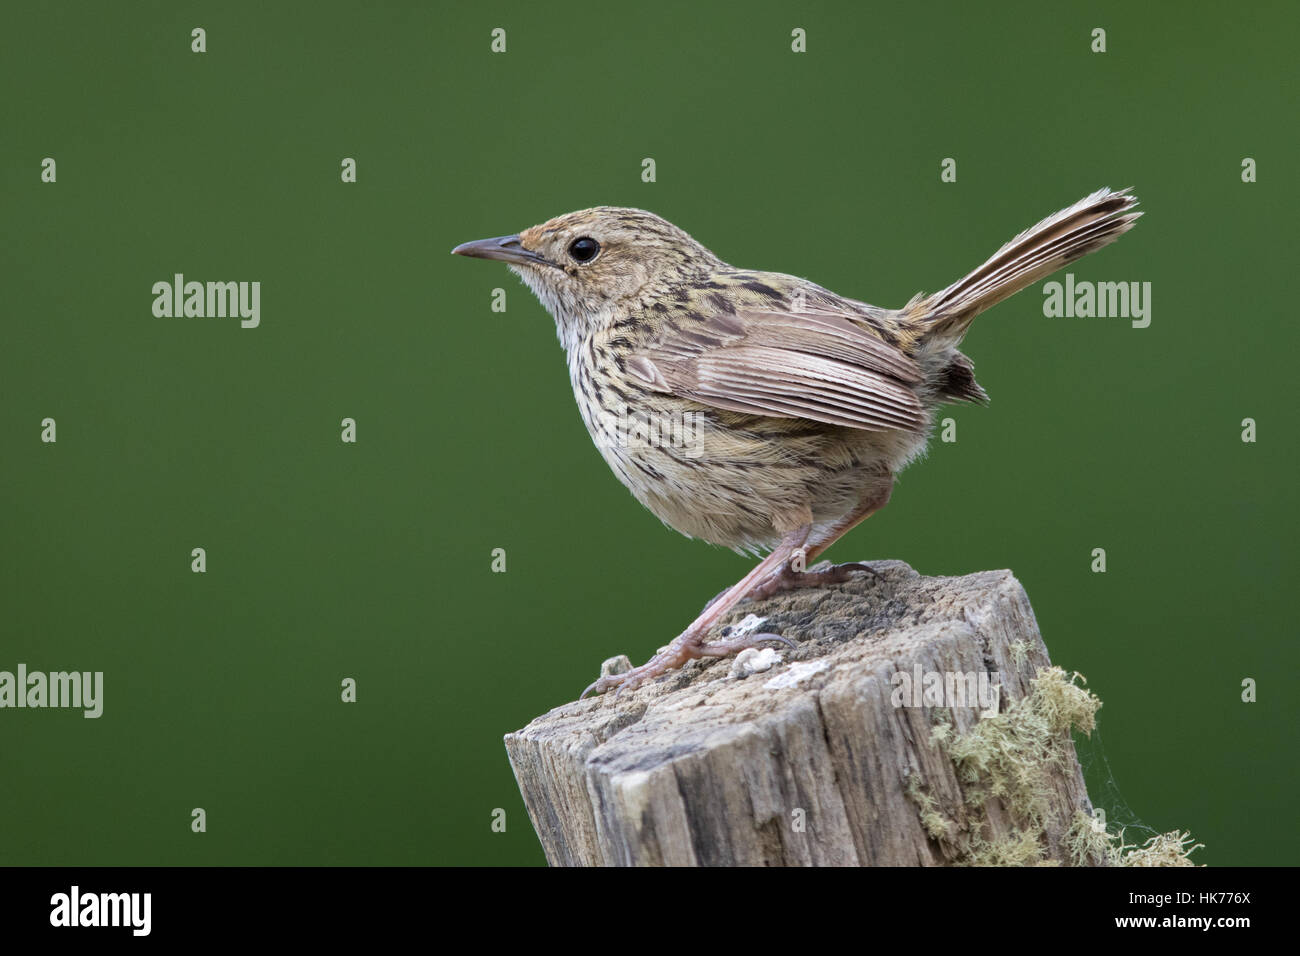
[452,189,1141,696]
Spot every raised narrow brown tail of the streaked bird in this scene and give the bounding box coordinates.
[909,189,1141,346]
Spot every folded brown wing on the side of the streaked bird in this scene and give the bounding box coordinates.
[625,310,924,431]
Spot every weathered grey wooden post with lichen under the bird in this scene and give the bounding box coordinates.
[506,562,1099,865]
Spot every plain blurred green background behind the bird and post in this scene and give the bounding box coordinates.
[0,3,1300,864]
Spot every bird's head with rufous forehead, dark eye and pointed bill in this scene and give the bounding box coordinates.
[451,206,722,345]
